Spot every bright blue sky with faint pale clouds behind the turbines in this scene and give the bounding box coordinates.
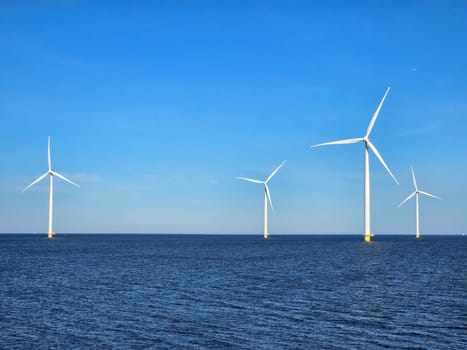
[0,1,467,234]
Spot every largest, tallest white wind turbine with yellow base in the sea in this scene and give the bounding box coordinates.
[312,87,399,242]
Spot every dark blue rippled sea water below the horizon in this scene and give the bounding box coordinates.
[0,234,467,349]
